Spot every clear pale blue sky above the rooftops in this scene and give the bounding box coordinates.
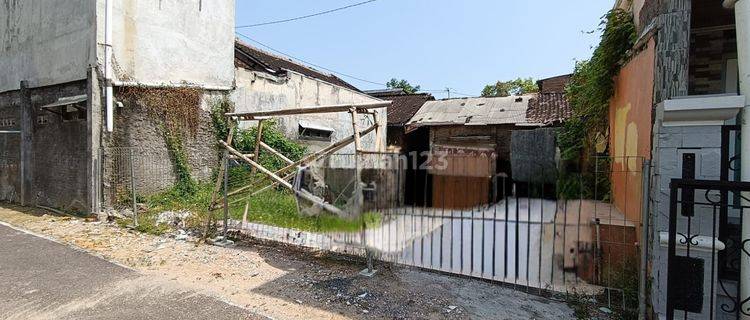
[236,0,613,97]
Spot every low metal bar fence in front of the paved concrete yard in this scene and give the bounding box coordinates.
[229,151,647,317]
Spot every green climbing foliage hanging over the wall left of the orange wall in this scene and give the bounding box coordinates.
[558,9,636,200]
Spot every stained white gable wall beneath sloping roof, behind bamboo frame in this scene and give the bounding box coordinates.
[232,68,387,164]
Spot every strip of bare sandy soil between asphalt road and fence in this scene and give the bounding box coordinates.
[0,205,574,319]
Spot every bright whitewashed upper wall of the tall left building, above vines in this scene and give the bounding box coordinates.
[97,0,235,89]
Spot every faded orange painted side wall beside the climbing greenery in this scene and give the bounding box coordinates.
[609,39,655,225]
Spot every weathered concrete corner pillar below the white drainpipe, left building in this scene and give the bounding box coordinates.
[86,67,102,214]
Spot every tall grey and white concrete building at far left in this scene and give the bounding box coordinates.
[0,0,234,212]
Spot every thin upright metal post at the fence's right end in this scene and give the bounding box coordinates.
[638,159,651,320]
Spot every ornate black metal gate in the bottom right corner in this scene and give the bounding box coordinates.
[666,179,750,319]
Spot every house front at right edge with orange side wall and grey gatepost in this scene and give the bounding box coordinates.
[609,0,750,319]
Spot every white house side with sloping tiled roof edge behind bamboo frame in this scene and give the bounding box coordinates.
[231,41,388,159]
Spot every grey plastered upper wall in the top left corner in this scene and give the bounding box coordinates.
[0,0,95,92]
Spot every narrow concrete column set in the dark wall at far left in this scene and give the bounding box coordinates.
[20,81,34,206]
